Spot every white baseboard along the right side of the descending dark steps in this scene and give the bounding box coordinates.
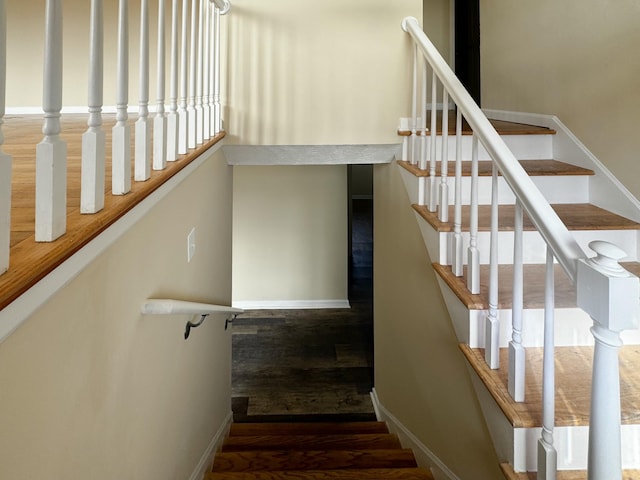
[371,388,460,480]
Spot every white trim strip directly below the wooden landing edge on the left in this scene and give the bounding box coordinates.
[0,140,224,343]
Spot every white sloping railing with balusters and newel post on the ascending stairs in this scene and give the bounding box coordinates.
[402,17,640,480]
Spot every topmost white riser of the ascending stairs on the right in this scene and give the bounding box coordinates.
[403,135,553,161]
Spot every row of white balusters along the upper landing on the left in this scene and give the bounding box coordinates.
[0,0,230,274]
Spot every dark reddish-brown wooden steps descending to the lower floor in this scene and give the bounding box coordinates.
[205,422,433,480]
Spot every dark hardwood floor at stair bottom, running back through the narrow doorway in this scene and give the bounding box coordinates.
[232,200,375,422]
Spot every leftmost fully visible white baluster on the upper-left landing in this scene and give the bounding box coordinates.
[36,0,67,242]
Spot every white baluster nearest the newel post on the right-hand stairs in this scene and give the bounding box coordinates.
[536,246,558,480]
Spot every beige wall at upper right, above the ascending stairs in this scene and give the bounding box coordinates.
[480,0,640,197]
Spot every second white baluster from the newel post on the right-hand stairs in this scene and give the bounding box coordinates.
[507,200,524,402]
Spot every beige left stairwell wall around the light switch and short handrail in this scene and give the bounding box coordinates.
[0,149,232,480]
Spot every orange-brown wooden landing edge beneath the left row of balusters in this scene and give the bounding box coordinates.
[0,132,225,310]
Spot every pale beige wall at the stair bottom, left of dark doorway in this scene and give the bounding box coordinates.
[233,165,348,302]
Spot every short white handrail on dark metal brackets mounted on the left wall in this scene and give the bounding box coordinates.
[140,298,244,340]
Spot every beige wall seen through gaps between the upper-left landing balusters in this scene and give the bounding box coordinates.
[7,0,164,107]
